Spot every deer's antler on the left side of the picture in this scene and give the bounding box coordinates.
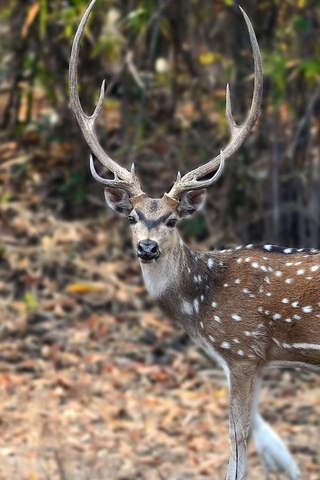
[69,0,143,196]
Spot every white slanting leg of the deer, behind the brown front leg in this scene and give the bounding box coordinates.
[252,381,301,480]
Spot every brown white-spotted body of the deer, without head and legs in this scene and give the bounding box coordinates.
[142,244,320,367]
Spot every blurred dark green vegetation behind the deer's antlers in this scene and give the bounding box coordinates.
[0,0,320,248]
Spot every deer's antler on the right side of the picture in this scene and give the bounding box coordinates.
[167,7,263,200]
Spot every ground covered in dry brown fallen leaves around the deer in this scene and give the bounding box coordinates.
[0,141,320,480]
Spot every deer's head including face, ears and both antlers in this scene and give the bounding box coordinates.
[69,0,263,262]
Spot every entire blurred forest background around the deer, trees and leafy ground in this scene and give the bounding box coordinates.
[0,0,320,480]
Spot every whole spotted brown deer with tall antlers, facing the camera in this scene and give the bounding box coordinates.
[69,0,320,480]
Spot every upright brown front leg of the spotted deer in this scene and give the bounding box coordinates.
[226,363,257,480]
